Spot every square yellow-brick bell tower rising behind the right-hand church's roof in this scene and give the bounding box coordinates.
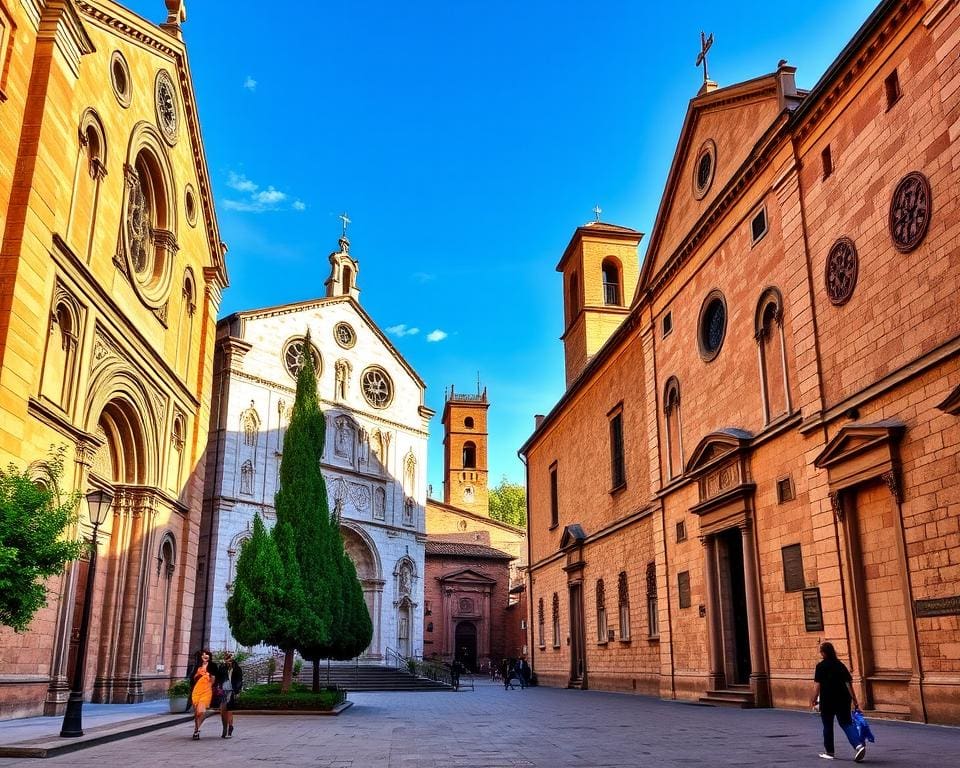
[557,220,643,387]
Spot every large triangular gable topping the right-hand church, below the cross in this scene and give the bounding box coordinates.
[635,66,800,300]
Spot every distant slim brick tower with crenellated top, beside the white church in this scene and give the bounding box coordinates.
[443,384,490,515]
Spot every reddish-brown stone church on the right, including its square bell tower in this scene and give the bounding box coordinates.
[521,0,960,724]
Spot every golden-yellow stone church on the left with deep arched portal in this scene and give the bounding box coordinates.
[0,0,227,718]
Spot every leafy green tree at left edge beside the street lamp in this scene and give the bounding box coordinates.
[0,449,87,632]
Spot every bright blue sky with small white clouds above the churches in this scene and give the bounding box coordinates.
[127,0,875,495]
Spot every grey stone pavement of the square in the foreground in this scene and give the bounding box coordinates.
[0,684,960,768]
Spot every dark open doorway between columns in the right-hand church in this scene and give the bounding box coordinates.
[717,528,751,685]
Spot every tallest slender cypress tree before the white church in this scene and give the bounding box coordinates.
[274,331,343,690]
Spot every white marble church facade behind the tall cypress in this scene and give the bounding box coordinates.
[193,230,433,661]
